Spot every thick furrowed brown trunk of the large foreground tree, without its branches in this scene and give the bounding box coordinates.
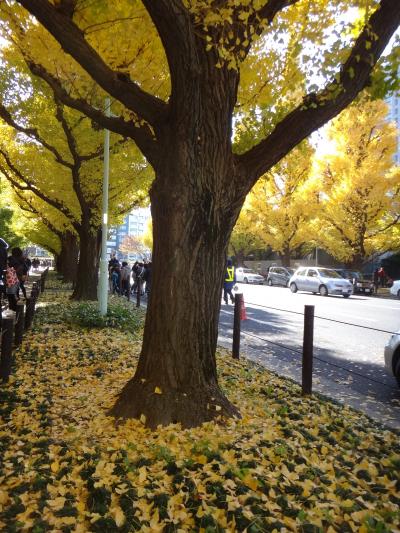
[111,93,245,428]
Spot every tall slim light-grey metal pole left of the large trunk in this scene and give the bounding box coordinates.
[98,98,110,315]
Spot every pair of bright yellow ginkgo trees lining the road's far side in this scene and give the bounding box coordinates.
[231,97,400,268]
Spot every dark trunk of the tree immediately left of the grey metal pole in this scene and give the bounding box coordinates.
[71,223,101,300]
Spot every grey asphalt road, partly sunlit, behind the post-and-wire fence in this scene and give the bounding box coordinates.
[219,283,400,429]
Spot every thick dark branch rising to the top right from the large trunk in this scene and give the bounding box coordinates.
[236,0,400,185]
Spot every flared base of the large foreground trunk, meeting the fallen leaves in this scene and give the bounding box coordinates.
[109,378,241,429]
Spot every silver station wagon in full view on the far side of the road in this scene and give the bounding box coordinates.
[289,267,353,298]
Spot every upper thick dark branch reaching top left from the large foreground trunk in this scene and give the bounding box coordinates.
[17,0,168,125]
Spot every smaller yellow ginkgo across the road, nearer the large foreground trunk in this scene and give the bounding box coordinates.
[239,141,319,266]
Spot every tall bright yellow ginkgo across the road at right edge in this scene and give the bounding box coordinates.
[312,98,400,269]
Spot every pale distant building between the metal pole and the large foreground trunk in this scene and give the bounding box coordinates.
[107,207,151,261]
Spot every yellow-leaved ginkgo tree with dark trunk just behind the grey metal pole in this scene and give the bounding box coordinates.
[0,47,151,299]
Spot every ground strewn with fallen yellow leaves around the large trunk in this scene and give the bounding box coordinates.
[0,293,400,533]
